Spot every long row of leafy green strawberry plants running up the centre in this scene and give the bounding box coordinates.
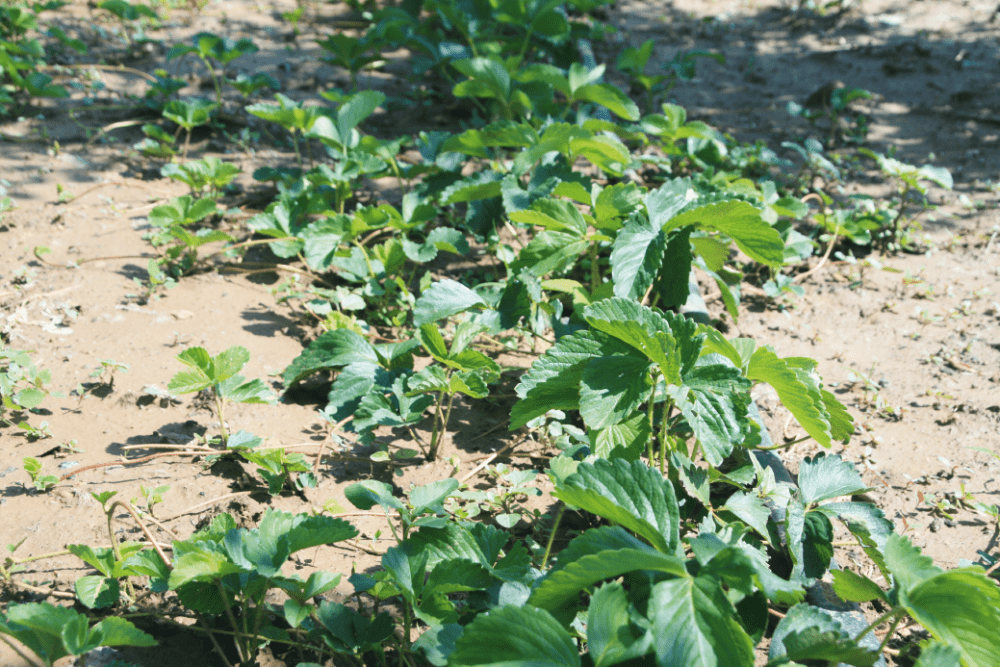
[0,0,988,667]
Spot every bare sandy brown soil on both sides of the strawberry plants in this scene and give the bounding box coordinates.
[0,0,1000,665]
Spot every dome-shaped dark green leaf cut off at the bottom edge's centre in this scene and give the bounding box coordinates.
[448,606,580,667]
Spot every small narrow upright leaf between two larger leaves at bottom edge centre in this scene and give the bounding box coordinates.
[587,583,652,667]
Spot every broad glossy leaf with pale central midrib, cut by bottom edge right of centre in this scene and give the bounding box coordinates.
[649,577,754,667]
